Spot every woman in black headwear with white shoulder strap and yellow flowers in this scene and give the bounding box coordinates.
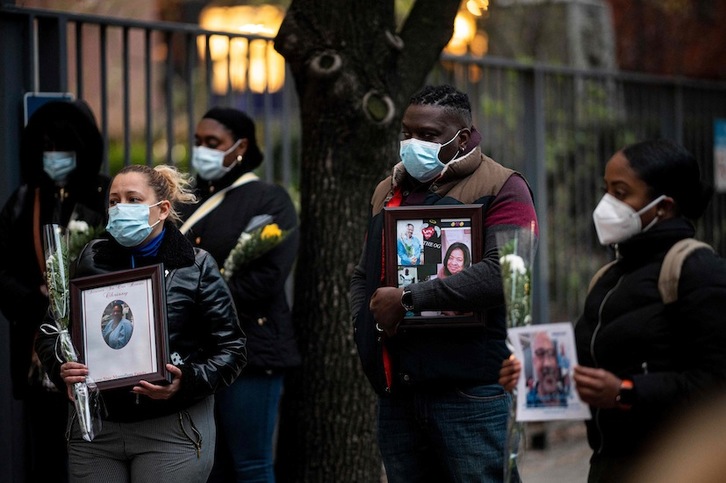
[182,107,301,482]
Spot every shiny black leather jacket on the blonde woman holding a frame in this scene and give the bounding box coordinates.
[36,222,246,421]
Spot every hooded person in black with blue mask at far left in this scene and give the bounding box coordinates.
[0,100,109,481]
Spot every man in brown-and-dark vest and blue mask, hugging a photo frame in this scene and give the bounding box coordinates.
[350,85,537,483]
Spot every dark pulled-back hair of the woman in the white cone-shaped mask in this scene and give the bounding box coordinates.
[622,139,713,220]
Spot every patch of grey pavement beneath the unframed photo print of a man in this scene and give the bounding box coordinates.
[518,421,592,483]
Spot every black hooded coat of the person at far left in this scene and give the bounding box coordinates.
[0,101,109,399]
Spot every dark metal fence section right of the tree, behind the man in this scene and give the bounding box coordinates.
[432,57,726,322]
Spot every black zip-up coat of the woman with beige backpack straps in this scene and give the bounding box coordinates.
[575,218,726,459]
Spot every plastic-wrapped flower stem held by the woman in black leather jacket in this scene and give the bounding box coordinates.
[41,225,101,441]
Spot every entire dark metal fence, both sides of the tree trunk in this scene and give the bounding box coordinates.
[0,6,726,322]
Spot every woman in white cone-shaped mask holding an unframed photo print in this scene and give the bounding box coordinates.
[500,140,726,483]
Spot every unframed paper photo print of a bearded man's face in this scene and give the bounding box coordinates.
[508,322,591,421]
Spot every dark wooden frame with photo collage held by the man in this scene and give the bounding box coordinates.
[383,205,484,328]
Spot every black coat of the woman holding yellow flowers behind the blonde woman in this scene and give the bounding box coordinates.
[186,165,300,373]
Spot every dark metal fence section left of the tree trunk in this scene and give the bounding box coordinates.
[0,6,299,190]
